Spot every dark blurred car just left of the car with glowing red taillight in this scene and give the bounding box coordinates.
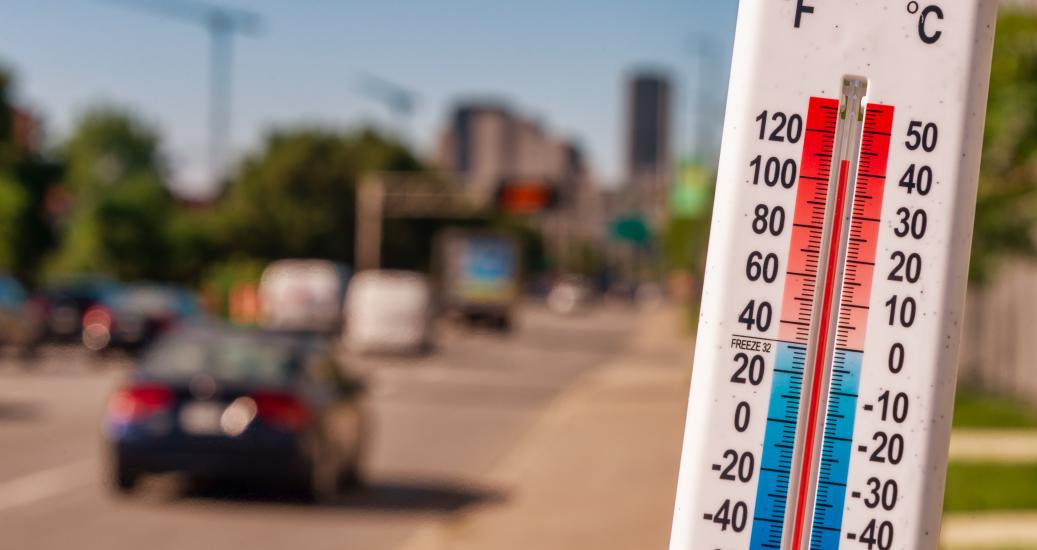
[40,277,121,342]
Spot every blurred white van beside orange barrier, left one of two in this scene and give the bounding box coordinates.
[259,259,349,334]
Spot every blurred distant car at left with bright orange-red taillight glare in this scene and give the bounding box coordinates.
[82,284,201,352]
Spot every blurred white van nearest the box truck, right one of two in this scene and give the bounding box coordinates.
[343,270,432,354]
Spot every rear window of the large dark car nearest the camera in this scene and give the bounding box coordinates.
[143,334,296,384]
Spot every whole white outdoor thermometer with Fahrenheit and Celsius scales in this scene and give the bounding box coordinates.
[670,0,997,550]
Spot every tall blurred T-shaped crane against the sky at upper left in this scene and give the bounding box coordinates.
[104,0,262,182]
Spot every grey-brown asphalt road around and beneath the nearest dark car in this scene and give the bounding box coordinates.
[0,307,635,550]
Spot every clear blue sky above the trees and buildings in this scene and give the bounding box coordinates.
[0,0,737,194]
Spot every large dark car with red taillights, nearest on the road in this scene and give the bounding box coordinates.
[104,327,364,500]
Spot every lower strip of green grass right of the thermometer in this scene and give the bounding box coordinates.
[944,462,1037,513]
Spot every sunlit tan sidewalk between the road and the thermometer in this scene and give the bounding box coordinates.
[401,308,692,550]
